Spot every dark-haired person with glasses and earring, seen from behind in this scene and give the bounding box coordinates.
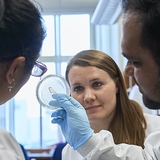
[0,0,47,160]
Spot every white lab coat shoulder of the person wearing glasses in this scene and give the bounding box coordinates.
[0,129,25,160]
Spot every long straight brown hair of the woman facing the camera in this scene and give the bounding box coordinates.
[65,50,147,147]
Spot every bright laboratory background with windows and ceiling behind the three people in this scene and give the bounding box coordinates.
[0,0,160,160]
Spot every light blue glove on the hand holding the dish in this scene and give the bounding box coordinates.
[50,93,93,149]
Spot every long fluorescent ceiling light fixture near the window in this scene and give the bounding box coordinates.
[91,0,122,24]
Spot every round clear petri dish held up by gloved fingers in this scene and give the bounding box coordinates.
[36,74,70,110]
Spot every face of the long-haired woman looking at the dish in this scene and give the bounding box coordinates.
[68,66,118,123]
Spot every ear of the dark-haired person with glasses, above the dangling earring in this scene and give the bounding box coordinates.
[6,57,25,84]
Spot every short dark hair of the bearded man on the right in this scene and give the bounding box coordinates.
[122,0,160,66]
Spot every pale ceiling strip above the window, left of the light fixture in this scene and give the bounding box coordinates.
[33,0,99,14]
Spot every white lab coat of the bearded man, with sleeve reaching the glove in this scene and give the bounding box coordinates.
[77,130,160,160]
